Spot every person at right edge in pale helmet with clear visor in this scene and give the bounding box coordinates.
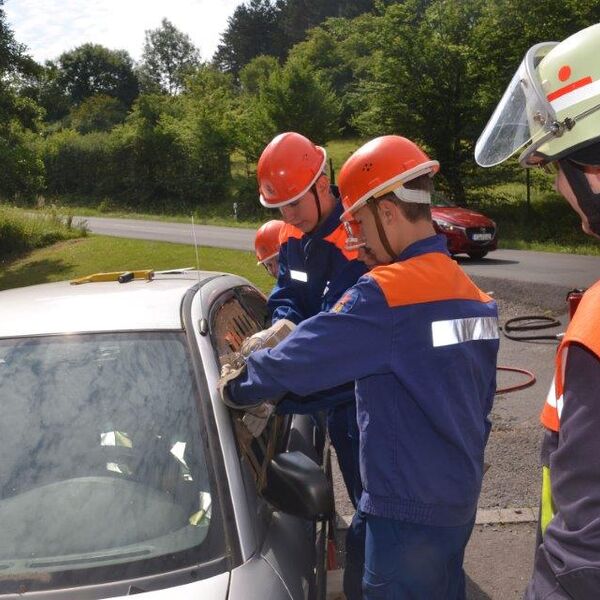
[475,25,600,600]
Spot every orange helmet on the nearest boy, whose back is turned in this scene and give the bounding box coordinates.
[338,135,440,220]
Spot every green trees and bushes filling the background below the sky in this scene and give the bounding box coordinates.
[0,0,600,246]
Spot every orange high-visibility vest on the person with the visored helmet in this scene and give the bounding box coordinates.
[540,281,600,534]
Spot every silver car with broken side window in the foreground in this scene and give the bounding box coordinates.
[0,270,333,600]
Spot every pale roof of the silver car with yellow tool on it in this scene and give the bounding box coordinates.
[0,270,230,338]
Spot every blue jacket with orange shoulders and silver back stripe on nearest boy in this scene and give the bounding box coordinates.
[230,236,499,526]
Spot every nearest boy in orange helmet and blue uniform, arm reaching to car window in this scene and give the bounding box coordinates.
[221,136,499,600]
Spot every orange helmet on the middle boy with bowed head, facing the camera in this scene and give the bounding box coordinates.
[256,131,327,208]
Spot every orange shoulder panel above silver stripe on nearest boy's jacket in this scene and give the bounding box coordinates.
[369,252,492,307]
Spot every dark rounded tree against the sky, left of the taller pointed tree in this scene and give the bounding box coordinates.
[56,44,139,108]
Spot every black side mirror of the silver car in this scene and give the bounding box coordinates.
[263,451,335,520]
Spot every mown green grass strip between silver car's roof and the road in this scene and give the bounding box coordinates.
[0,235,273,293]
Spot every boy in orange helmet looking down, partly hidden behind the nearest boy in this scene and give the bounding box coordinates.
[257,132,367,600]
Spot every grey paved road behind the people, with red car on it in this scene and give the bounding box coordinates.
[79,217,600,288]
